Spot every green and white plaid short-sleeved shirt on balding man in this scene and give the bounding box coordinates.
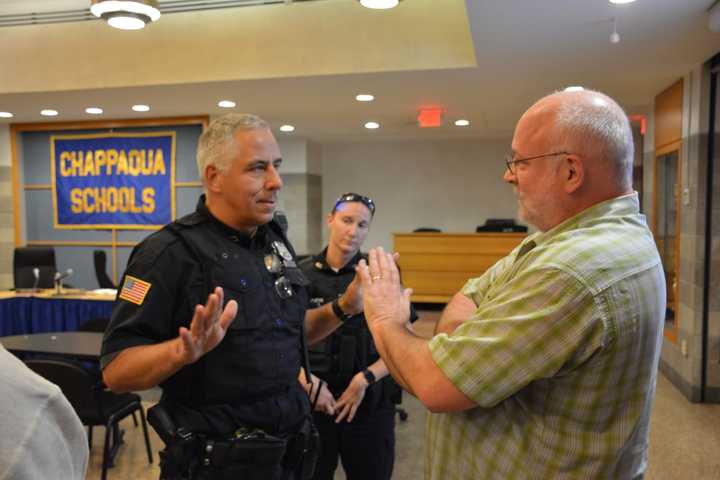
[425,194,666,480]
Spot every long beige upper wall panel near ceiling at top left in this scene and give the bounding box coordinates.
[0,0,476,93]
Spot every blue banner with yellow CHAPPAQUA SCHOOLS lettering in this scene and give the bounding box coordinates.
[50,132,175,228]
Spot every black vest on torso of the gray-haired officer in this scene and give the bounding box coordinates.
[165,213,307,406]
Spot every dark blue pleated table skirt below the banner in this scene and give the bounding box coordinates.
[0,297,114,336]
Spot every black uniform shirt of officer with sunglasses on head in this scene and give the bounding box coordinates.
[300,247,417,415]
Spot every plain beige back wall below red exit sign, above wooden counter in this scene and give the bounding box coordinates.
[321,138,517,250]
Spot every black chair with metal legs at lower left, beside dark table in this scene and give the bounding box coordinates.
[25,359,153,480]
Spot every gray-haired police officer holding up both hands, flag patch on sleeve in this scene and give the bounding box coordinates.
[101,114,362,480]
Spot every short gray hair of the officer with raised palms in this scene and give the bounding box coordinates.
[197,113,270,182]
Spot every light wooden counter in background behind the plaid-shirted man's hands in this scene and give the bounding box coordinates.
[393,233,527,303]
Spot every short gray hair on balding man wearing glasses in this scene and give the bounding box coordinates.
[554,90,634,190]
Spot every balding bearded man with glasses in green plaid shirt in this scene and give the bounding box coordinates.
[360,91,666,480]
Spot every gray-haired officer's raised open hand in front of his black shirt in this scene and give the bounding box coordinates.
[177,287,238,364]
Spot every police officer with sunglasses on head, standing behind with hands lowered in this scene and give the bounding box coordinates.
[300,193,417,480]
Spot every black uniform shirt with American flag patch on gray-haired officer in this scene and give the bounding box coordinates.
[101,195,309,434]
